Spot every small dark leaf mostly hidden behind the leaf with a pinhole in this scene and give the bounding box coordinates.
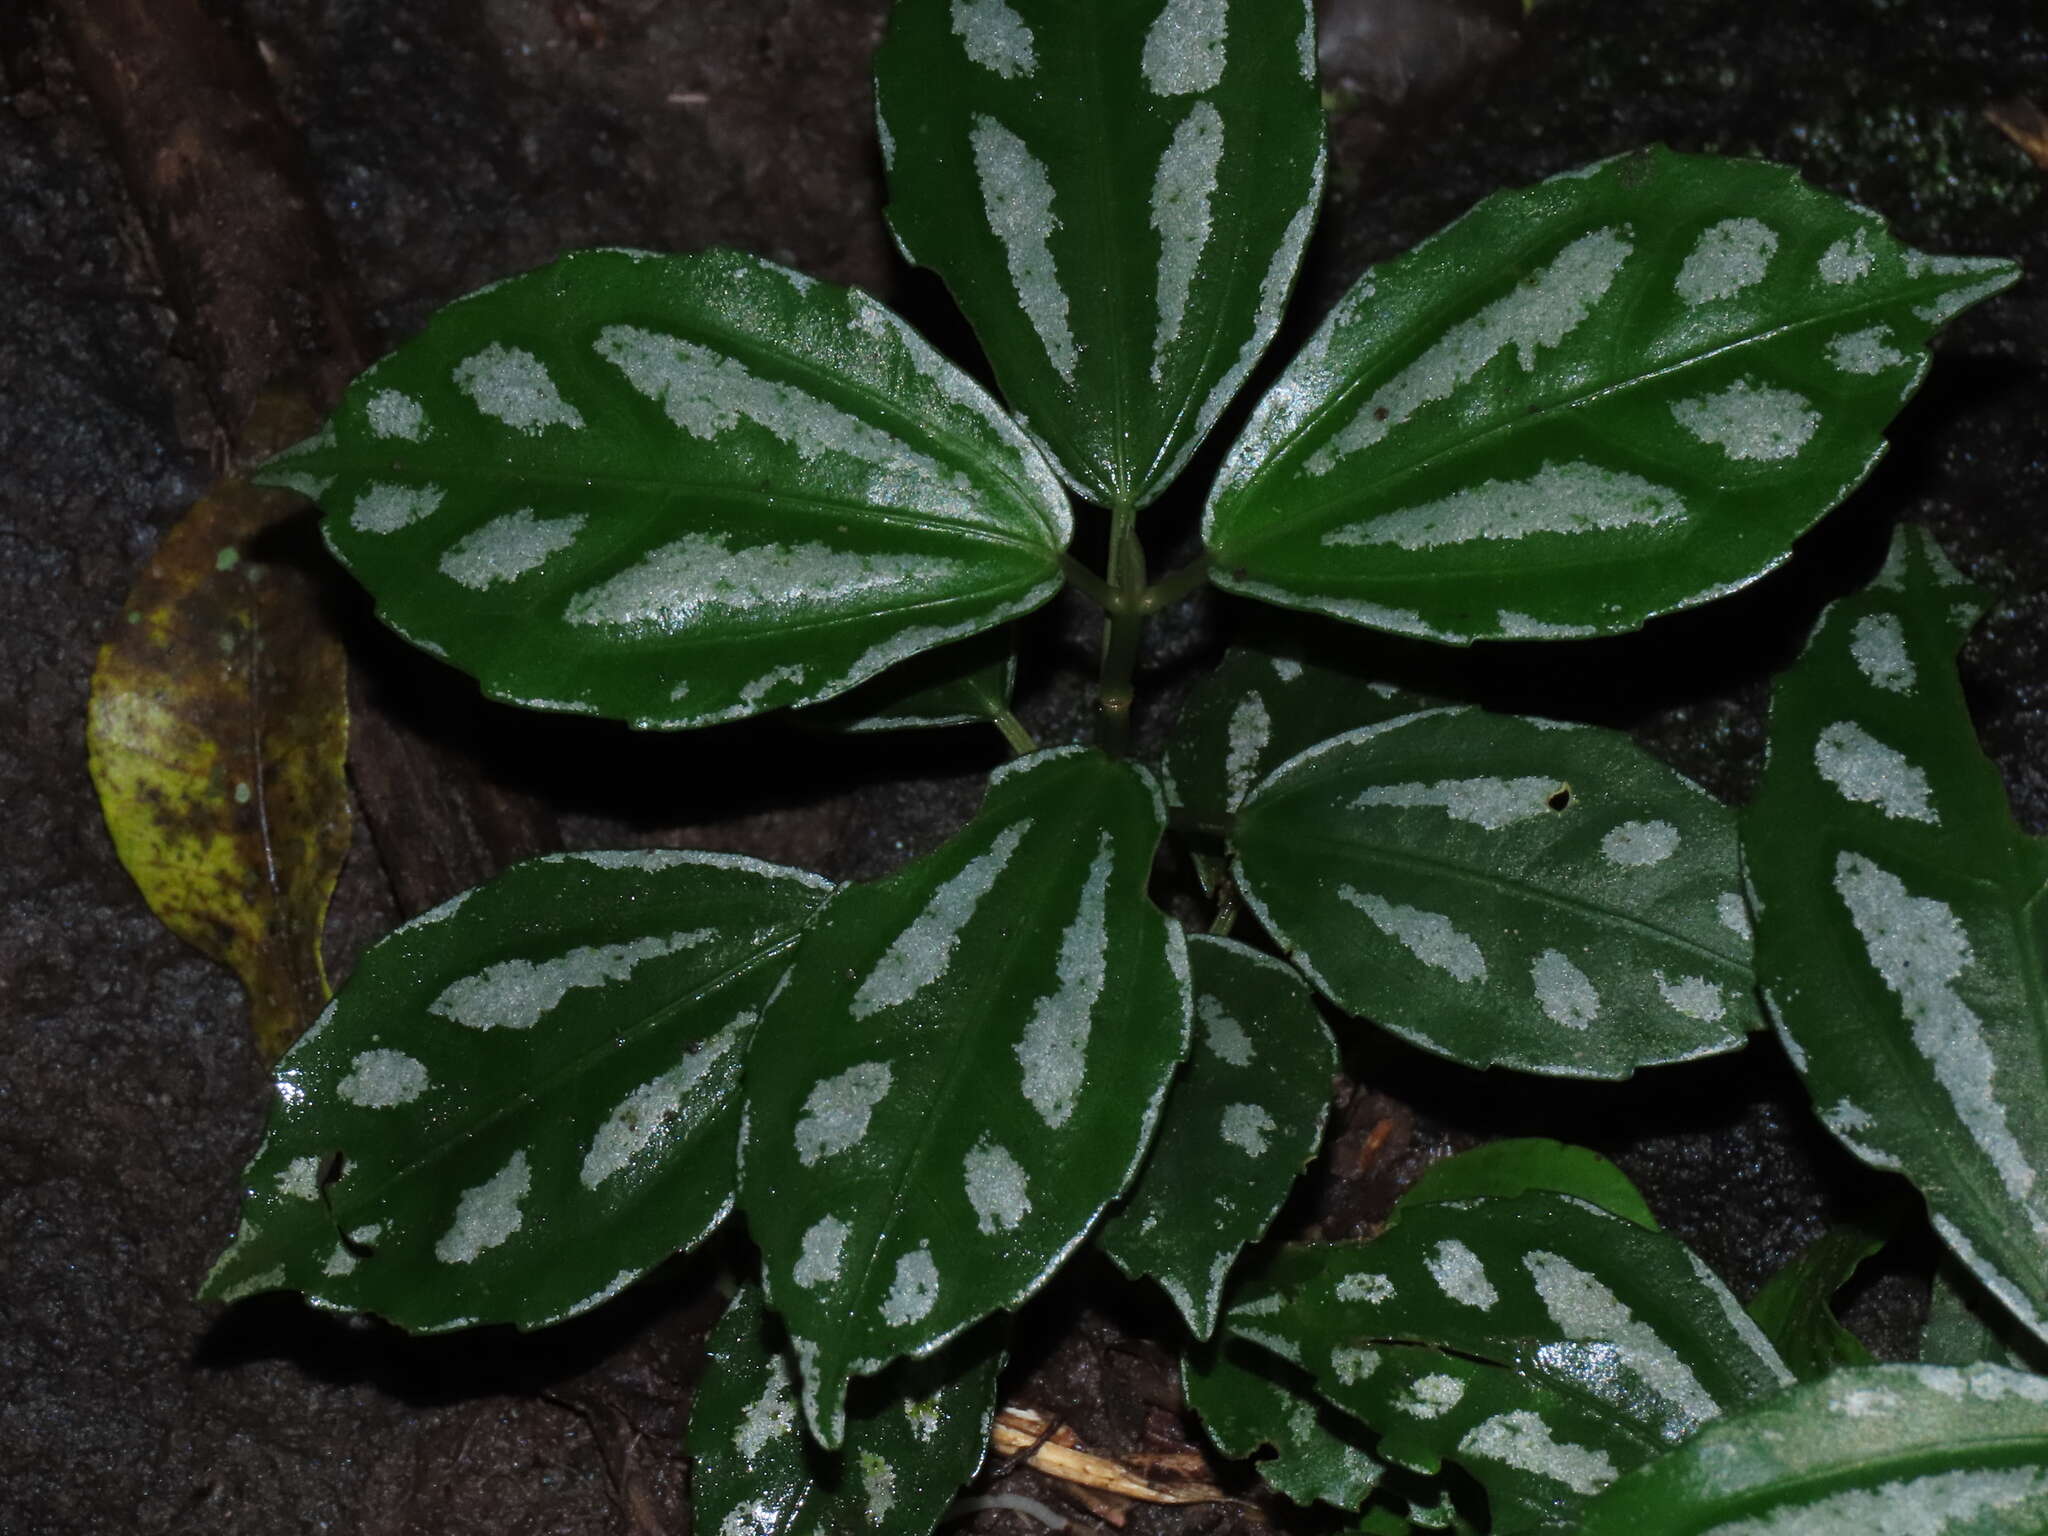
[1161,647,1442,827]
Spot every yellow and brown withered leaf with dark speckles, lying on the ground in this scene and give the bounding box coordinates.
[86,481,350,1061]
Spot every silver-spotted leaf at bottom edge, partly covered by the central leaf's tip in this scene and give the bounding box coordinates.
[688,1286,1001,1536]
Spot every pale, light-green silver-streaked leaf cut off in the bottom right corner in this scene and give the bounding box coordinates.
[1579,1366,2048,1536]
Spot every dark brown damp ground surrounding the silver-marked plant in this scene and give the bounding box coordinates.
[0,0,2048,1536]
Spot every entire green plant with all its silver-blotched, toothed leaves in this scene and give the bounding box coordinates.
[180,0,2048,1536]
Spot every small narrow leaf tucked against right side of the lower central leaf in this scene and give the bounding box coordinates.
[1098,934,1337,1339]
